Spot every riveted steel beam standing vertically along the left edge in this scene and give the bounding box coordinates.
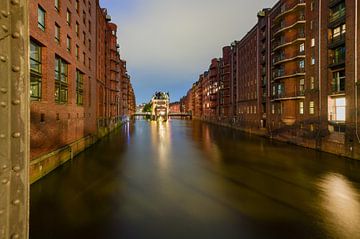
[0,0,30,239]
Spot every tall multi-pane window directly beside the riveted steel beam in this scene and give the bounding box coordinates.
[30,41,42,100]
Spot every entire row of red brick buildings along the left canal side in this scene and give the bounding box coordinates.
[29,0,135,182]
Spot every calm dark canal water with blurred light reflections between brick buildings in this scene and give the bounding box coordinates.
[30,120,360,239]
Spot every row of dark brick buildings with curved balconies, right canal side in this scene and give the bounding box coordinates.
[183,0,360,161]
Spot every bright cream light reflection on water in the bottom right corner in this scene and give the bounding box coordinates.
[317,173,360,238]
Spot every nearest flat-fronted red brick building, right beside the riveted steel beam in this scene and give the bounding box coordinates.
[29,0,96,159]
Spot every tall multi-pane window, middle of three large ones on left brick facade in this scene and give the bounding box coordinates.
[55,56,68,104]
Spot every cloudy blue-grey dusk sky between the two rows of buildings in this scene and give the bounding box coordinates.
[100,0,276,103]
